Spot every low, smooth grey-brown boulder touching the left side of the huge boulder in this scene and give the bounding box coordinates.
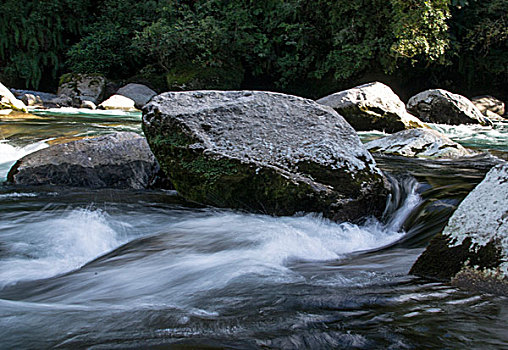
[7,132,165,189]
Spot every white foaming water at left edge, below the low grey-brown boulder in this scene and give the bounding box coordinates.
[0,209,123,285]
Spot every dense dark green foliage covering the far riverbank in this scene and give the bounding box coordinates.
[0,0,508,97]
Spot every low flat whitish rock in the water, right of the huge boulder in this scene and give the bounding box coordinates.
[365,129,473,158]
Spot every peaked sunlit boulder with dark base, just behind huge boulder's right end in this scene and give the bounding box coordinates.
[316,82,425,132]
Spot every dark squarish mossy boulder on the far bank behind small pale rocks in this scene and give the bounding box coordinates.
[57,73,106,107]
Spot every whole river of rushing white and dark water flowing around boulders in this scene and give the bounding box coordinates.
[0,110,508,349]
